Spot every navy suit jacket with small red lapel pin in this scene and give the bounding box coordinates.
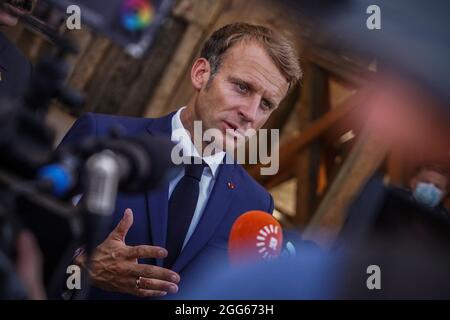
[62,113,273,299]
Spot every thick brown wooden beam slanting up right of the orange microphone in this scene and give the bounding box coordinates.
[303,127,389,248]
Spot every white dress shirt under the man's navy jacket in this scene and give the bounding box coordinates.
[169,107,225,250]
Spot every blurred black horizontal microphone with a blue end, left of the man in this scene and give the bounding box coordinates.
[37,134,180,198]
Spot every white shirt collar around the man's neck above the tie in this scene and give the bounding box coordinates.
[171,106,225,177]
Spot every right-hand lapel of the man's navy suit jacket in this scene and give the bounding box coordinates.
[172,164,235,272]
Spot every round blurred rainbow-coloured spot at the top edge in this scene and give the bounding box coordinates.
[121,0,155,32]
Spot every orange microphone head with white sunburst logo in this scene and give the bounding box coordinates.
[228,210,283,265]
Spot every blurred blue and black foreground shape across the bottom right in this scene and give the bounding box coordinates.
[180,175,450,300]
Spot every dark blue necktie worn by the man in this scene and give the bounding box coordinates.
[164,158,206,268]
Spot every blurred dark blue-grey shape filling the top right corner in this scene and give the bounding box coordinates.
[284,0,450,105]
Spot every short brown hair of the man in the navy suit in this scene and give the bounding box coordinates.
[200,22,302,87]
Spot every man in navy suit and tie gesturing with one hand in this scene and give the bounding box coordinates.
[63,23,301,299]
